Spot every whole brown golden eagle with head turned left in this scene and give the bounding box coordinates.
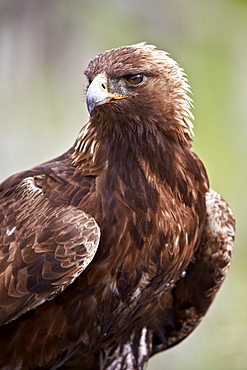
[0,43,234,370]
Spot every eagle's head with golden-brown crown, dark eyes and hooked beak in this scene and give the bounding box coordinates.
[85,43,193,141]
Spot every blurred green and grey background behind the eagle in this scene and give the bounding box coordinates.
[0,0,247,370]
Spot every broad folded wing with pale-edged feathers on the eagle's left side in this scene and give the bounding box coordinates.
[0,177,100,325]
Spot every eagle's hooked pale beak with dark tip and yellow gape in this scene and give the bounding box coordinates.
[86,74,128,116]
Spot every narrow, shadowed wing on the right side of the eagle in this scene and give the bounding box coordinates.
[153,189,235,354]
